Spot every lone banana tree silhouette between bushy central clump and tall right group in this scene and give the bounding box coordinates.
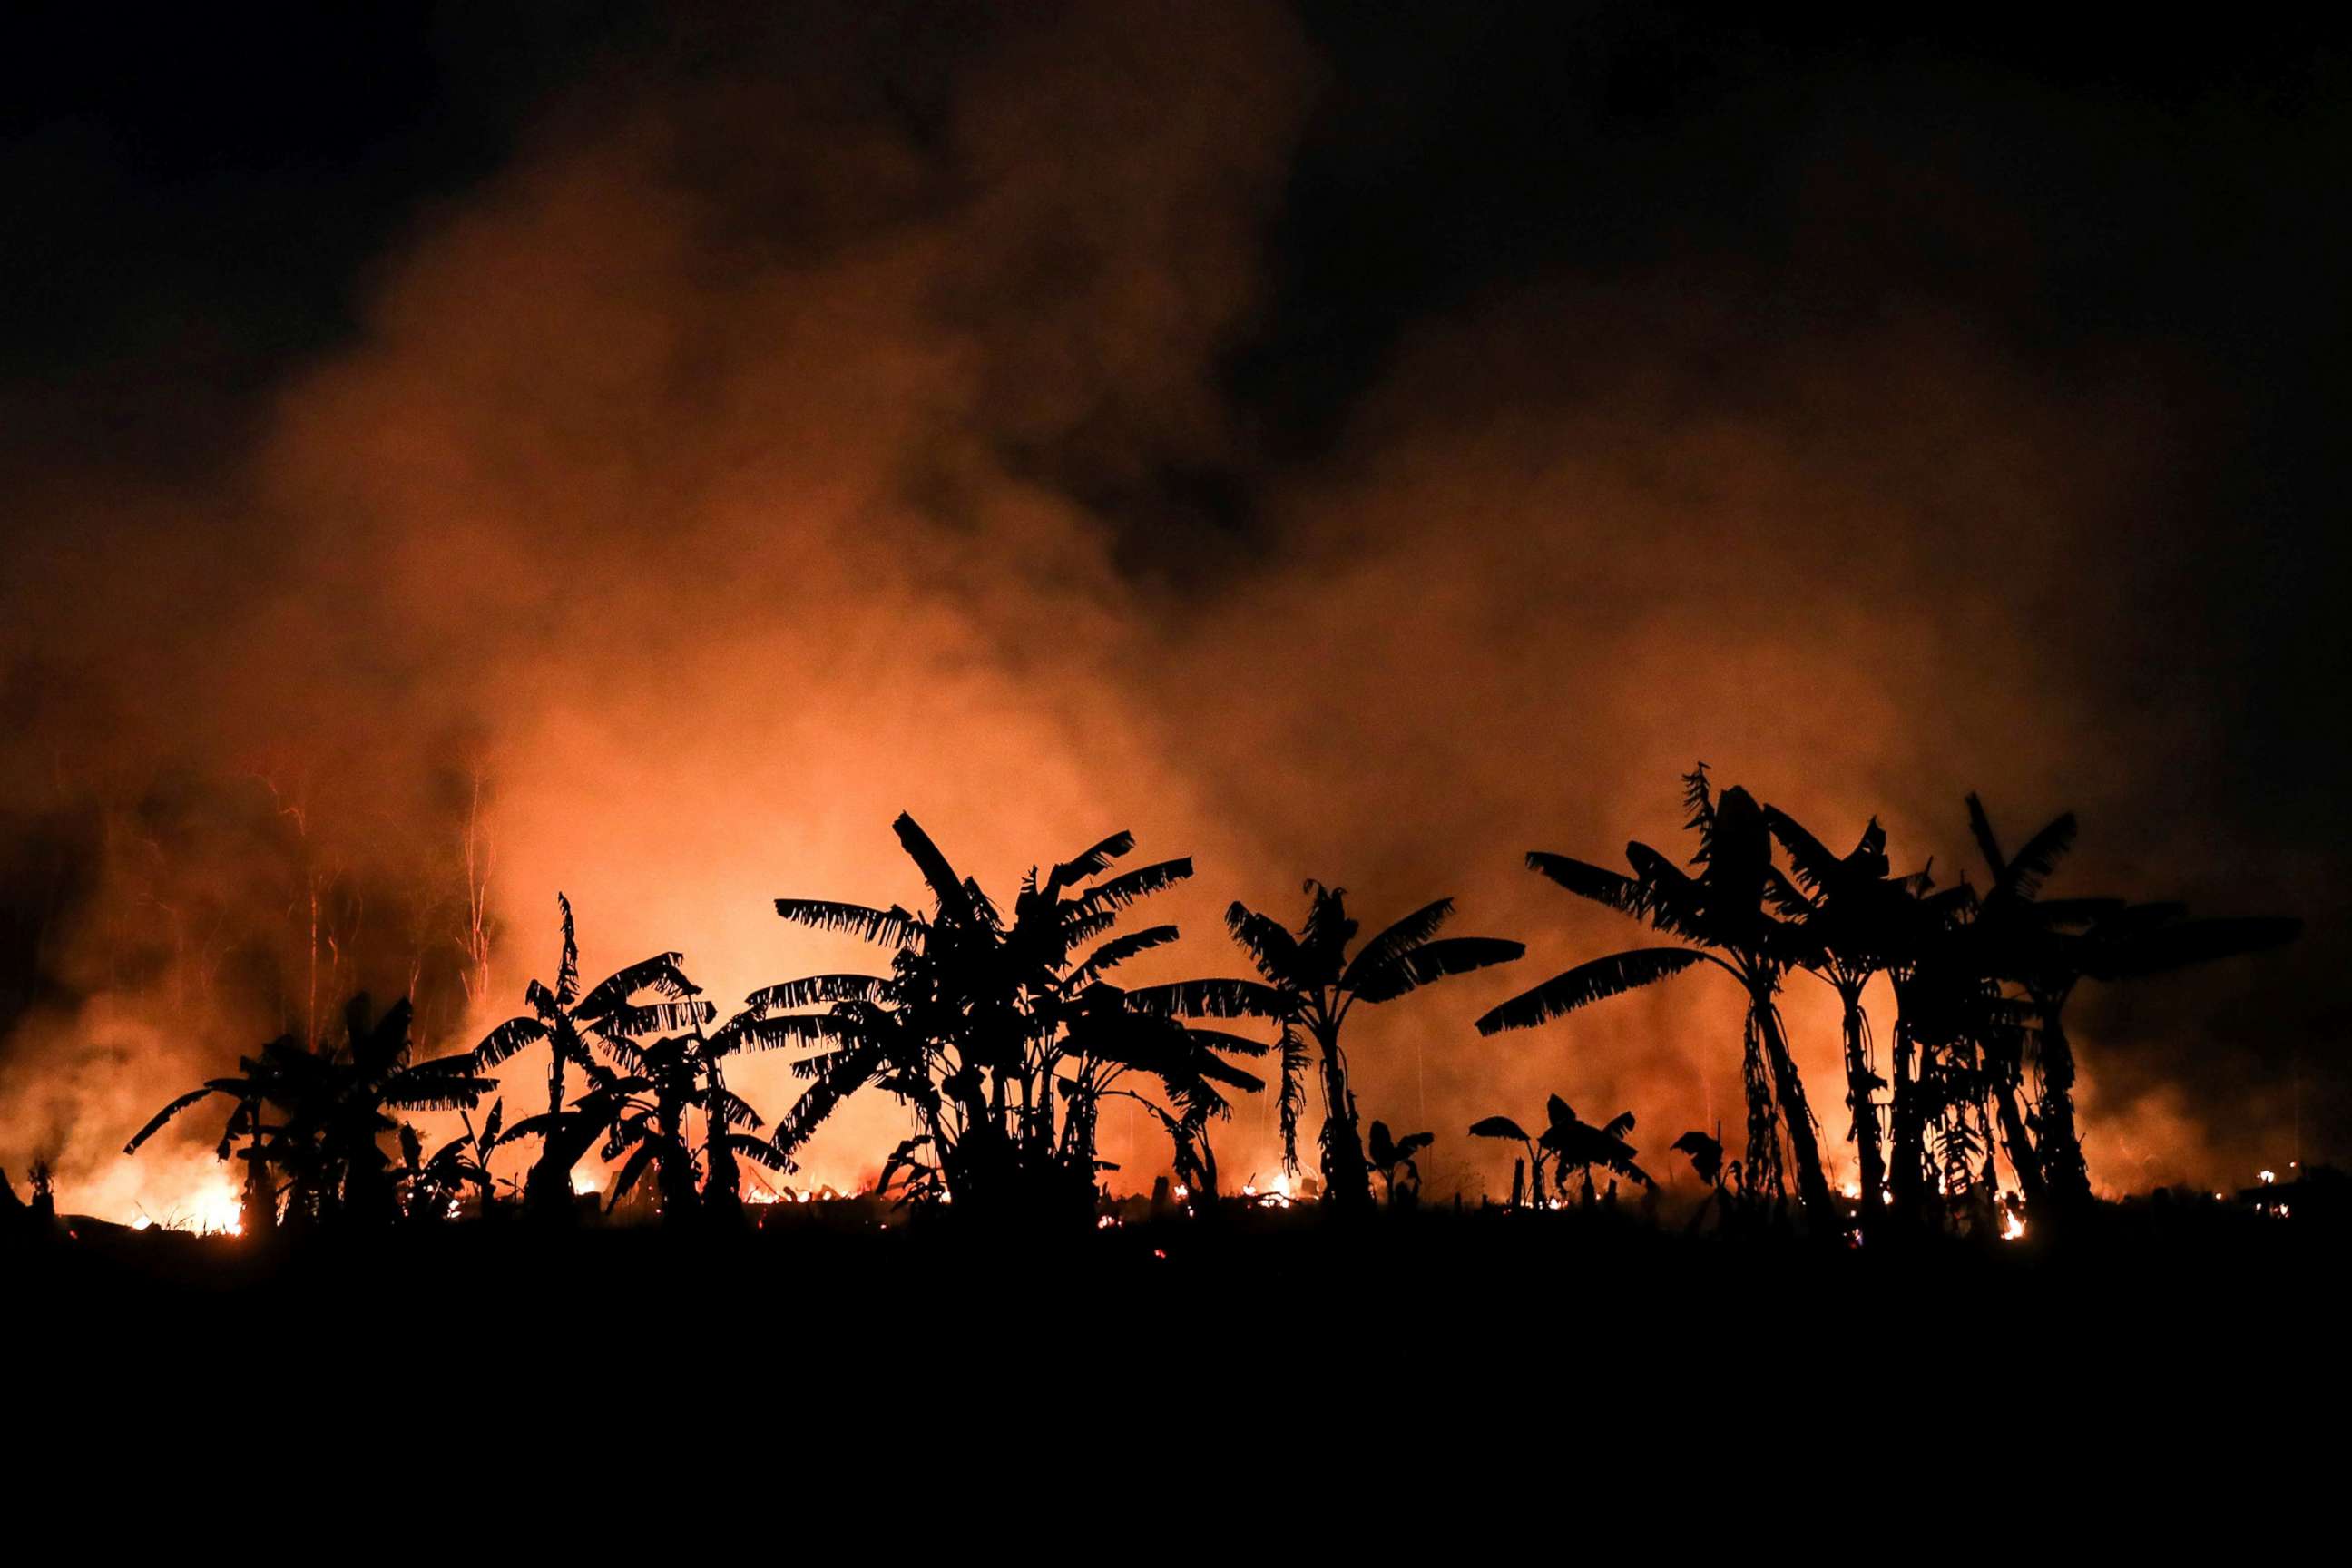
[1225,882,1526,1209]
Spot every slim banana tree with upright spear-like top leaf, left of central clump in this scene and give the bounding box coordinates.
[473,893,708,1218]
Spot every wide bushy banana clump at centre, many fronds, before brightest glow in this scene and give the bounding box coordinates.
[761,813,1270,1218]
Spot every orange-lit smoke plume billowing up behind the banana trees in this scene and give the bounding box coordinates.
[0,5,2340,1215]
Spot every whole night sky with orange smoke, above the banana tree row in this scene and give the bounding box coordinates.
[0,3,2352,1210]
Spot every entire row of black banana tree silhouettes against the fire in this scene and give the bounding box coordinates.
[92,799,2298,1237]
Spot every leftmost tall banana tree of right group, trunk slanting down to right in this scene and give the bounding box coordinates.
[1477,764,1835,1222]
